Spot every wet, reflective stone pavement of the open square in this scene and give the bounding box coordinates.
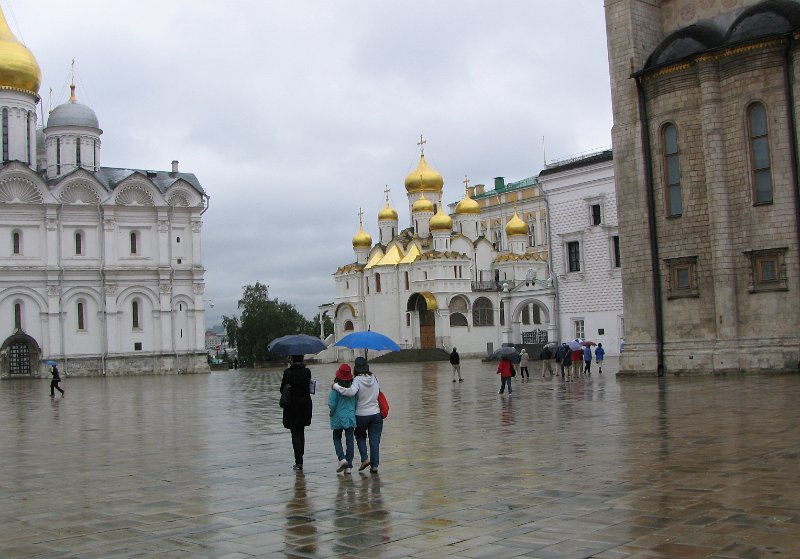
[0,360,800,559]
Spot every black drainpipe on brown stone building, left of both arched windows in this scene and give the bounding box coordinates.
[636,76,664,377]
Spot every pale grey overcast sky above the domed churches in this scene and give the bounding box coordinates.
[0,0,612,326]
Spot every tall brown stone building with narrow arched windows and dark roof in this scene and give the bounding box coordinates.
[605,0,800,374]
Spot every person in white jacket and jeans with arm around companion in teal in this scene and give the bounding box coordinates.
[333,357,383,474]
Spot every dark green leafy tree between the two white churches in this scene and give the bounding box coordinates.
[231,282,312,364]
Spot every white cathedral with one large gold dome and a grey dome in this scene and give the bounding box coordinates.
[0,10,208,378]
